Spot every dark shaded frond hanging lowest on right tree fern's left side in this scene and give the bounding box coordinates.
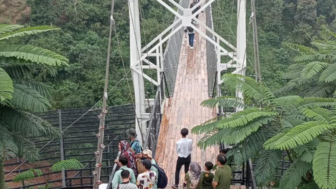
[255,150,282,185]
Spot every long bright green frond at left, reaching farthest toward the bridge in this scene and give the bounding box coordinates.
[0,45,69,66]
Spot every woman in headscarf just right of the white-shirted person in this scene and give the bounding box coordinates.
[185,162,202,189]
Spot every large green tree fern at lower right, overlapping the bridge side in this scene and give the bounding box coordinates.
[192,74,336,189]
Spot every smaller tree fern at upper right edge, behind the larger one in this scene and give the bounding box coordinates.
[277,27,336,97]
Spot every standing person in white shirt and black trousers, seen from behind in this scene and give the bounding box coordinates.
[172,128,192,189]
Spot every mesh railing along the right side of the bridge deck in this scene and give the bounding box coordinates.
[205,0,218,97]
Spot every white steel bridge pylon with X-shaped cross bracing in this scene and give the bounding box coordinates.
[128,0,246,140]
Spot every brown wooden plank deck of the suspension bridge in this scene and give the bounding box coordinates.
[156,13,219,188]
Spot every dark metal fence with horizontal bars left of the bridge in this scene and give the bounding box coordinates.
[5,105,135,189]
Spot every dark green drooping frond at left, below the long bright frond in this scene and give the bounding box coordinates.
[12,84,51,112]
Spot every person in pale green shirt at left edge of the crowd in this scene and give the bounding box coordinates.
[112,156,136,189]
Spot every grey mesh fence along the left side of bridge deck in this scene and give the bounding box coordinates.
[163,0,189,96]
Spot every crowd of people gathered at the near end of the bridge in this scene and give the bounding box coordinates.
[112,128,232,189]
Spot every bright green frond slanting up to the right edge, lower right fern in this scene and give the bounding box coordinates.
[268,121,335,150]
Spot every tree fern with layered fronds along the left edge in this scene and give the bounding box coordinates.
[0,25,68,188]
